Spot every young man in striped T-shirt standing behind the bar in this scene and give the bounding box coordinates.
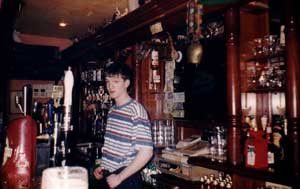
[94,63,153,189]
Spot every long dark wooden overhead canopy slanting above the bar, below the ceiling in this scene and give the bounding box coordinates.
[62,0,255,63]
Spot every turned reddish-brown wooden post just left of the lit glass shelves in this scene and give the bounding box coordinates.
[225,7,242,165]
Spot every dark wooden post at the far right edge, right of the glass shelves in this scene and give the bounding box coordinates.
[284,0,300,177]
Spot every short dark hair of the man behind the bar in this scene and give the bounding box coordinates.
[105,62,134,91]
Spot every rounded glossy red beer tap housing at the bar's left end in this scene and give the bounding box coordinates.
[0,116,36,189]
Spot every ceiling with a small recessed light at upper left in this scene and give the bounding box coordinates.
[15,0,127,39]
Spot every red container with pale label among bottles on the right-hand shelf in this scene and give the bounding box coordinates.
[244,131,268,169]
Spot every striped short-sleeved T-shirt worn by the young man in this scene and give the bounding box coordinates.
[101,99,153,172]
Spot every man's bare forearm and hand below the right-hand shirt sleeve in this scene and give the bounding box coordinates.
[107,148,153,188]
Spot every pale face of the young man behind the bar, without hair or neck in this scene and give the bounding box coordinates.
[105,75,130,100]
